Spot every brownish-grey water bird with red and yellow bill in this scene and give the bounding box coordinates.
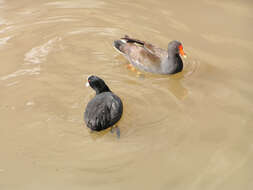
[114,35,186,74]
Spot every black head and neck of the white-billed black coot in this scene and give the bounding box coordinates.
[88,75,110,94]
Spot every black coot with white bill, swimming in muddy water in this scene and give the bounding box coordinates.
[84,76,123,136]
